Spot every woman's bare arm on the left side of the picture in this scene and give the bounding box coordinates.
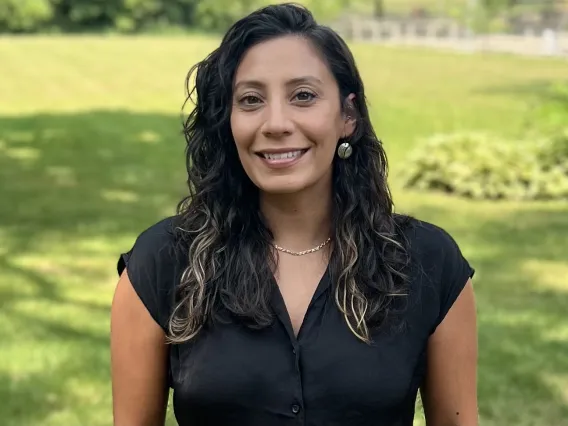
[110,270,168,426]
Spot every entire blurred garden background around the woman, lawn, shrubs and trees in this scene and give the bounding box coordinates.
[0,0,568,426]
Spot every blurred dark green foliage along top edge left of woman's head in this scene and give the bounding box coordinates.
[0,0,351,33]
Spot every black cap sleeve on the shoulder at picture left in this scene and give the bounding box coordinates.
[117,218,183,331]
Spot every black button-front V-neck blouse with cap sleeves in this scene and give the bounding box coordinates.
[118,218,474,426]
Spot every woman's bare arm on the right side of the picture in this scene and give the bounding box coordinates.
[421,280,478,426]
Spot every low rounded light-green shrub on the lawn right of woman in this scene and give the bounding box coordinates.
[403,131,568,200]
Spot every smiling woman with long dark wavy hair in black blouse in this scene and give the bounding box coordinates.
[111,5,477,426]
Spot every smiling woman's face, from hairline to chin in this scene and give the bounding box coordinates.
[231,36,354,194]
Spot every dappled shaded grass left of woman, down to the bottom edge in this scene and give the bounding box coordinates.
[0,111,186,426]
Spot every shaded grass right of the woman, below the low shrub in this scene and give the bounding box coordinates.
[406,198,568,426]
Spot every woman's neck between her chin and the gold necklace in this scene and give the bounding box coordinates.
[260,182,332,251]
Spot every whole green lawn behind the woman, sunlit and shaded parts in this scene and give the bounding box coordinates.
[0,37,568,426]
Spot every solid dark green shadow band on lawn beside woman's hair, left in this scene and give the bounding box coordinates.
[0,111,185,251]
